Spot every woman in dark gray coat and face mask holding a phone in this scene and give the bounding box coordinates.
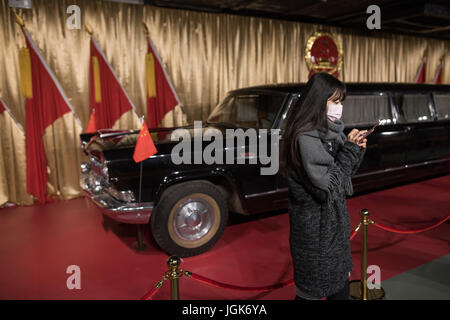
[281,73,367,300]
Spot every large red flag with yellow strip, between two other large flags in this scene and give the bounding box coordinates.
[89,36,135,130]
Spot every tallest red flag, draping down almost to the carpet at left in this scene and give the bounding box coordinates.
[23,30,77,203]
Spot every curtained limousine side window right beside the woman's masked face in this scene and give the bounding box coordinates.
[342,93,393,126]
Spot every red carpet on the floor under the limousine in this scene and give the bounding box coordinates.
[0,175,450,299]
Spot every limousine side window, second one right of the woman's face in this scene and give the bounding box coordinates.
[395,93,433,122]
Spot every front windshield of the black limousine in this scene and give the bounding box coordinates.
[207,92,286,129]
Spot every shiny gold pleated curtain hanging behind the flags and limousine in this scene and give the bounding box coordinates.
[0,0,450,205]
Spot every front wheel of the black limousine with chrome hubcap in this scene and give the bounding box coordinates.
[150,181,228,257]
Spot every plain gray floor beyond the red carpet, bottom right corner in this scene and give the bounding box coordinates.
[381,254,450,300]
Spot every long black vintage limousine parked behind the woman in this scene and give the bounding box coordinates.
[81,83,450,257]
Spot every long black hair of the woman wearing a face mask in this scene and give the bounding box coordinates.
[280,72,346,176]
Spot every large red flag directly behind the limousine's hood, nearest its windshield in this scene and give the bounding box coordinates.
[146,37,180,128]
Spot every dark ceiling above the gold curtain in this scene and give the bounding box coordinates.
[144,0,450,40]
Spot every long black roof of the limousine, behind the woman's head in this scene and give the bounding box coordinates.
[230,82,450,93]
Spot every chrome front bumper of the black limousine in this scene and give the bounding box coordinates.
[80,171,153,224]
